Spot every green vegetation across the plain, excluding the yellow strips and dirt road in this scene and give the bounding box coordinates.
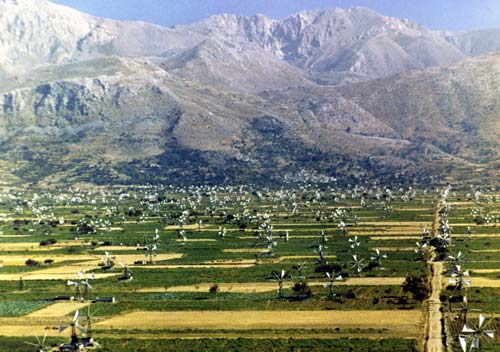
[0,188,500,351]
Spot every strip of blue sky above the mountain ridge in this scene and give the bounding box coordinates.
[52,0,500,30]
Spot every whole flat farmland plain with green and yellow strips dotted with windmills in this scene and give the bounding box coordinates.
[0,186,500,351]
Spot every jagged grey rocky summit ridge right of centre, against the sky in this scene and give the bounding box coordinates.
[177,7,465,78]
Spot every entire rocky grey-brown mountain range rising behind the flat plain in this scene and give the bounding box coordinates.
[0,0,500,184]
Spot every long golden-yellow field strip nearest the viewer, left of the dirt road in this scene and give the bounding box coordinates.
[94,310,422,337]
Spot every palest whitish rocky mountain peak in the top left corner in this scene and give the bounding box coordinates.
[0,0,204,73]
